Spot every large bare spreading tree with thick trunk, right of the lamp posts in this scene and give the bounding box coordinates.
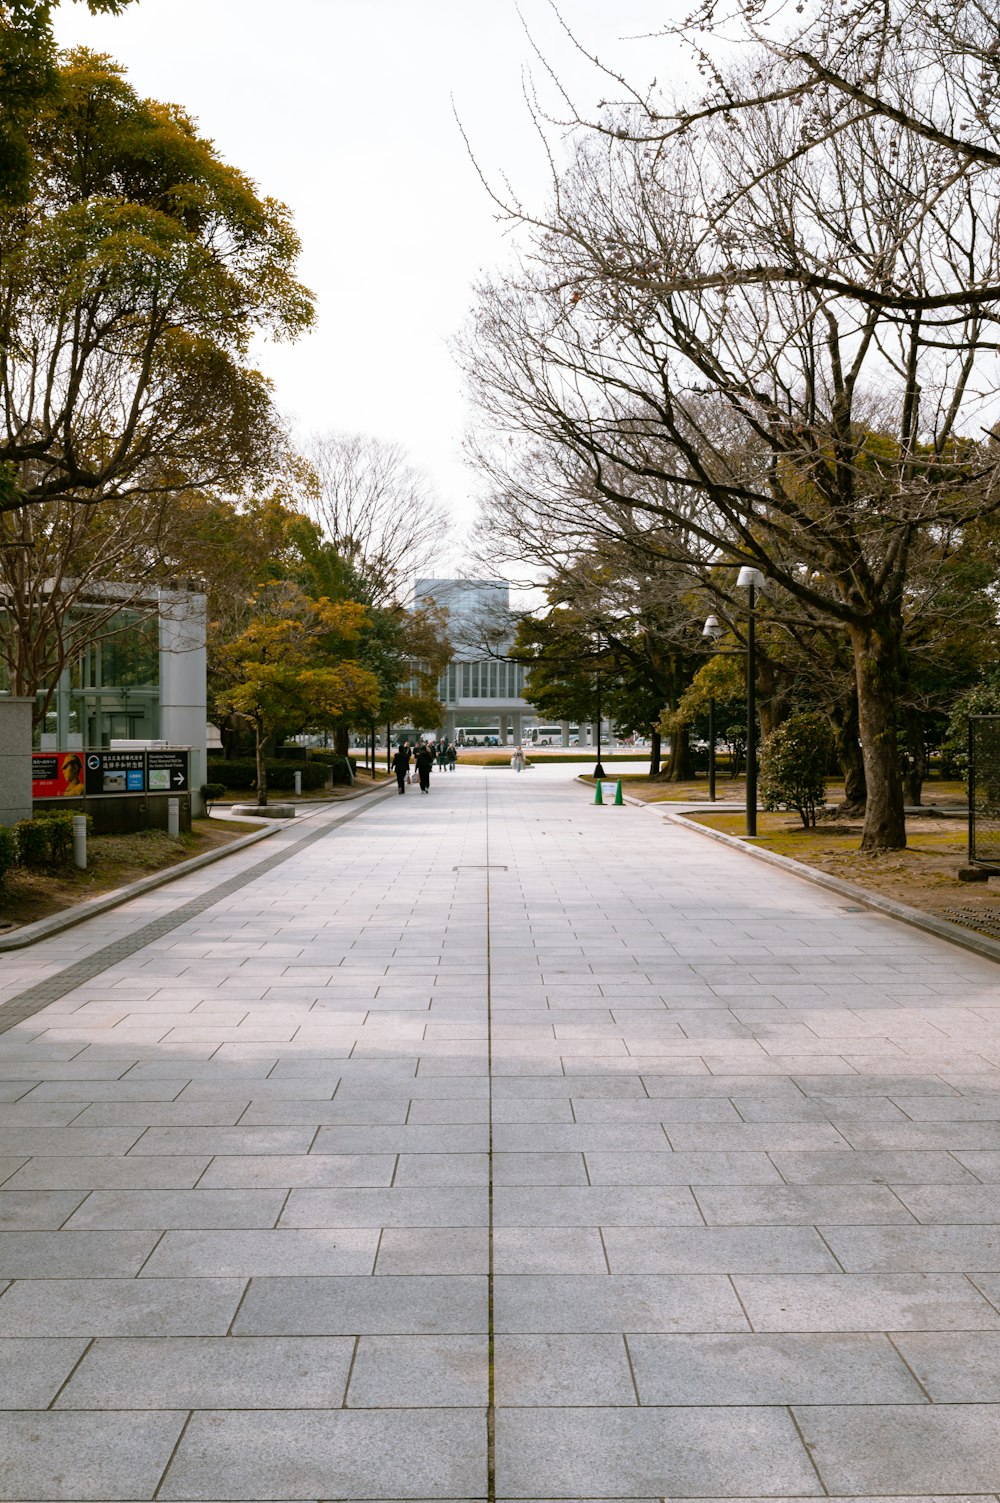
[465,17,1000,849]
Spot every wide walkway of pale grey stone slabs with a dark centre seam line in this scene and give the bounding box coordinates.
[0,768,1000,1503]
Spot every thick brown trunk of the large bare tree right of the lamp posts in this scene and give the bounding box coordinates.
[851,619,907,851]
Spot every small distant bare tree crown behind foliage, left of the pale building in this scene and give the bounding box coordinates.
[305,433,450,606]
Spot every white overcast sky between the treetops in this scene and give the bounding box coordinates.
[48,0,683,562]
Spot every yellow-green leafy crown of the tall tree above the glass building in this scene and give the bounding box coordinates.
[0,51,311,507]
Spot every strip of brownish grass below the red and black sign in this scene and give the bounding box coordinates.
[0,819,260,932]
